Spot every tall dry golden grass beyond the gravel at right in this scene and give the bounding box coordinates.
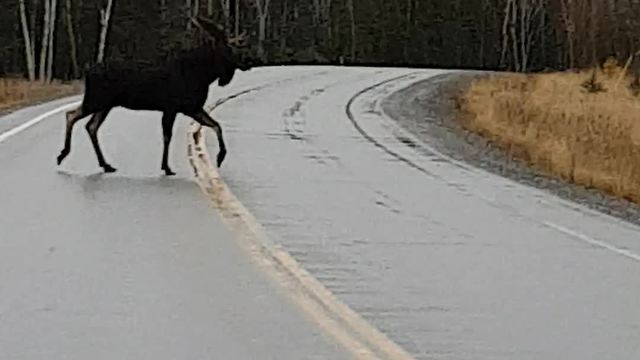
[460,64,640,203]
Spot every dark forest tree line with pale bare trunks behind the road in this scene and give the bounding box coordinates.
[0,0,640,81]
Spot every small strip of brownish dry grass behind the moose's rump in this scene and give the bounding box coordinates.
[0,78,81,111]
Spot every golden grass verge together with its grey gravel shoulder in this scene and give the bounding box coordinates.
[382,70,640,224]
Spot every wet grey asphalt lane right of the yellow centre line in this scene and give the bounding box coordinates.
[209,67,640,360]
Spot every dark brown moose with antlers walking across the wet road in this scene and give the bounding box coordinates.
[57,17,255,176]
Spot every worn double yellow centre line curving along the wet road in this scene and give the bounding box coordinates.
[187,71,413,360]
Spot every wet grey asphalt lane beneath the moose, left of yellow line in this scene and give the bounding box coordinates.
[0,87,349,360]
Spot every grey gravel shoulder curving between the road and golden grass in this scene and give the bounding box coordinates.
[382,71,640,225]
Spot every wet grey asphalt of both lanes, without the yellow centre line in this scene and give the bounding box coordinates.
[0,67,640,359]
